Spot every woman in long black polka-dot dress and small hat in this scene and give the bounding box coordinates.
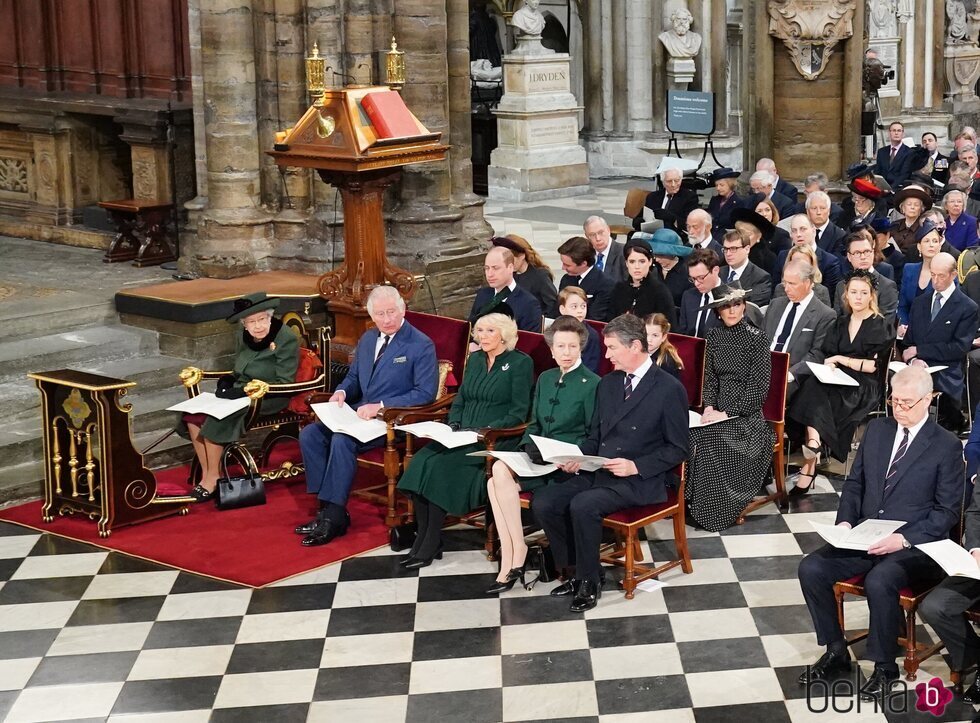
[684,284,775,532]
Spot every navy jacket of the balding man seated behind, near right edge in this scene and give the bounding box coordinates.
[902,288,977,402]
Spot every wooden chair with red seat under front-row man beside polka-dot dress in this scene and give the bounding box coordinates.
[599,464,694,600]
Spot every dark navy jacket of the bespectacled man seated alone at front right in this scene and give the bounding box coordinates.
[837,417,963,545]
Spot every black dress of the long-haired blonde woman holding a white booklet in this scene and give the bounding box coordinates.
[786,314,895,462]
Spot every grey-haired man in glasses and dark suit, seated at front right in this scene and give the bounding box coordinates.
[799,367,963,700]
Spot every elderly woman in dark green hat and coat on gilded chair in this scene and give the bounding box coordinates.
[177,292,299,502]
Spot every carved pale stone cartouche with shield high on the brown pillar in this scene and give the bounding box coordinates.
[769,0,856,80]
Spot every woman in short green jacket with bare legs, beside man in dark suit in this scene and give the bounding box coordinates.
[487,316,599,595]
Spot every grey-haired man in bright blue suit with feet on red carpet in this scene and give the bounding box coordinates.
[296,286,439,547]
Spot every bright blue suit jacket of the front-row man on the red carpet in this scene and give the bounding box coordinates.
[337,321,440,409]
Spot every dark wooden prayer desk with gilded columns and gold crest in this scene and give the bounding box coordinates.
[28,369,194,537]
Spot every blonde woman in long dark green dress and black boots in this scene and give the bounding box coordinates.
[398,312,534,570]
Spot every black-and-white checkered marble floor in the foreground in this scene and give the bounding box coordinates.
[0,478,973,723]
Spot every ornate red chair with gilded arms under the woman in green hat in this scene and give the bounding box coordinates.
[180,320,330,483]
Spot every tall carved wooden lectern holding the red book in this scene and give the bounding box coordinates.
[268,86,448,354]
